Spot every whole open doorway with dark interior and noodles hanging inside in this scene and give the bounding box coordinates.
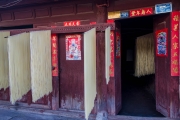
[117,16,163,117]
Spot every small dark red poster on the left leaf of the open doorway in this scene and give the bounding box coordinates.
[116,32,121,58]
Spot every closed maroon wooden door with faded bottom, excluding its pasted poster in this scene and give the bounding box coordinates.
[59,34,84,110]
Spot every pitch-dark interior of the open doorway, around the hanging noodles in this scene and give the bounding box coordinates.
[116,16,163,117]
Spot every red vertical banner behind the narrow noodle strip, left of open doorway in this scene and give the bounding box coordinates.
[109,31,114,77]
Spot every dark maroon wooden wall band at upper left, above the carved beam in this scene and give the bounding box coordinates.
[0,0,96,26]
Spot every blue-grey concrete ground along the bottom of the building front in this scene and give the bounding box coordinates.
[0,109,176,120]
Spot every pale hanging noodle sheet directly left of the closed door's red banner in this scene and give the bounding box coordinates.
[30,30,52,102]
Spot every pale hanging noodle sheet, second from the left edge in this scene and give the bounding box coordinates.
[8,33,31,104]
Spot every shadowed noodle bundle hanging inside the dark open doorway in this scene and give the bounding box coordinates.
[135,34,155,77]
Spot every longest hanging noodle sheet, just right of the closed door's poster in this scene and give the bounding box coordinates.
[84,28,97,120]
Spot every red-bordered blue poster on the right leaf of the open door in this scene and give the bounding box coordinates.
[156,28,168,57]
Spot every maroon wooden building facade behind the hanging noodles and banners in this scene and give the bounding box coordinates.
[0,0,180,118]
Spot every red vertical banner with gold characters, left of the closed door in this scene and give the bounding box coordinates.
[51,34,58,76]
